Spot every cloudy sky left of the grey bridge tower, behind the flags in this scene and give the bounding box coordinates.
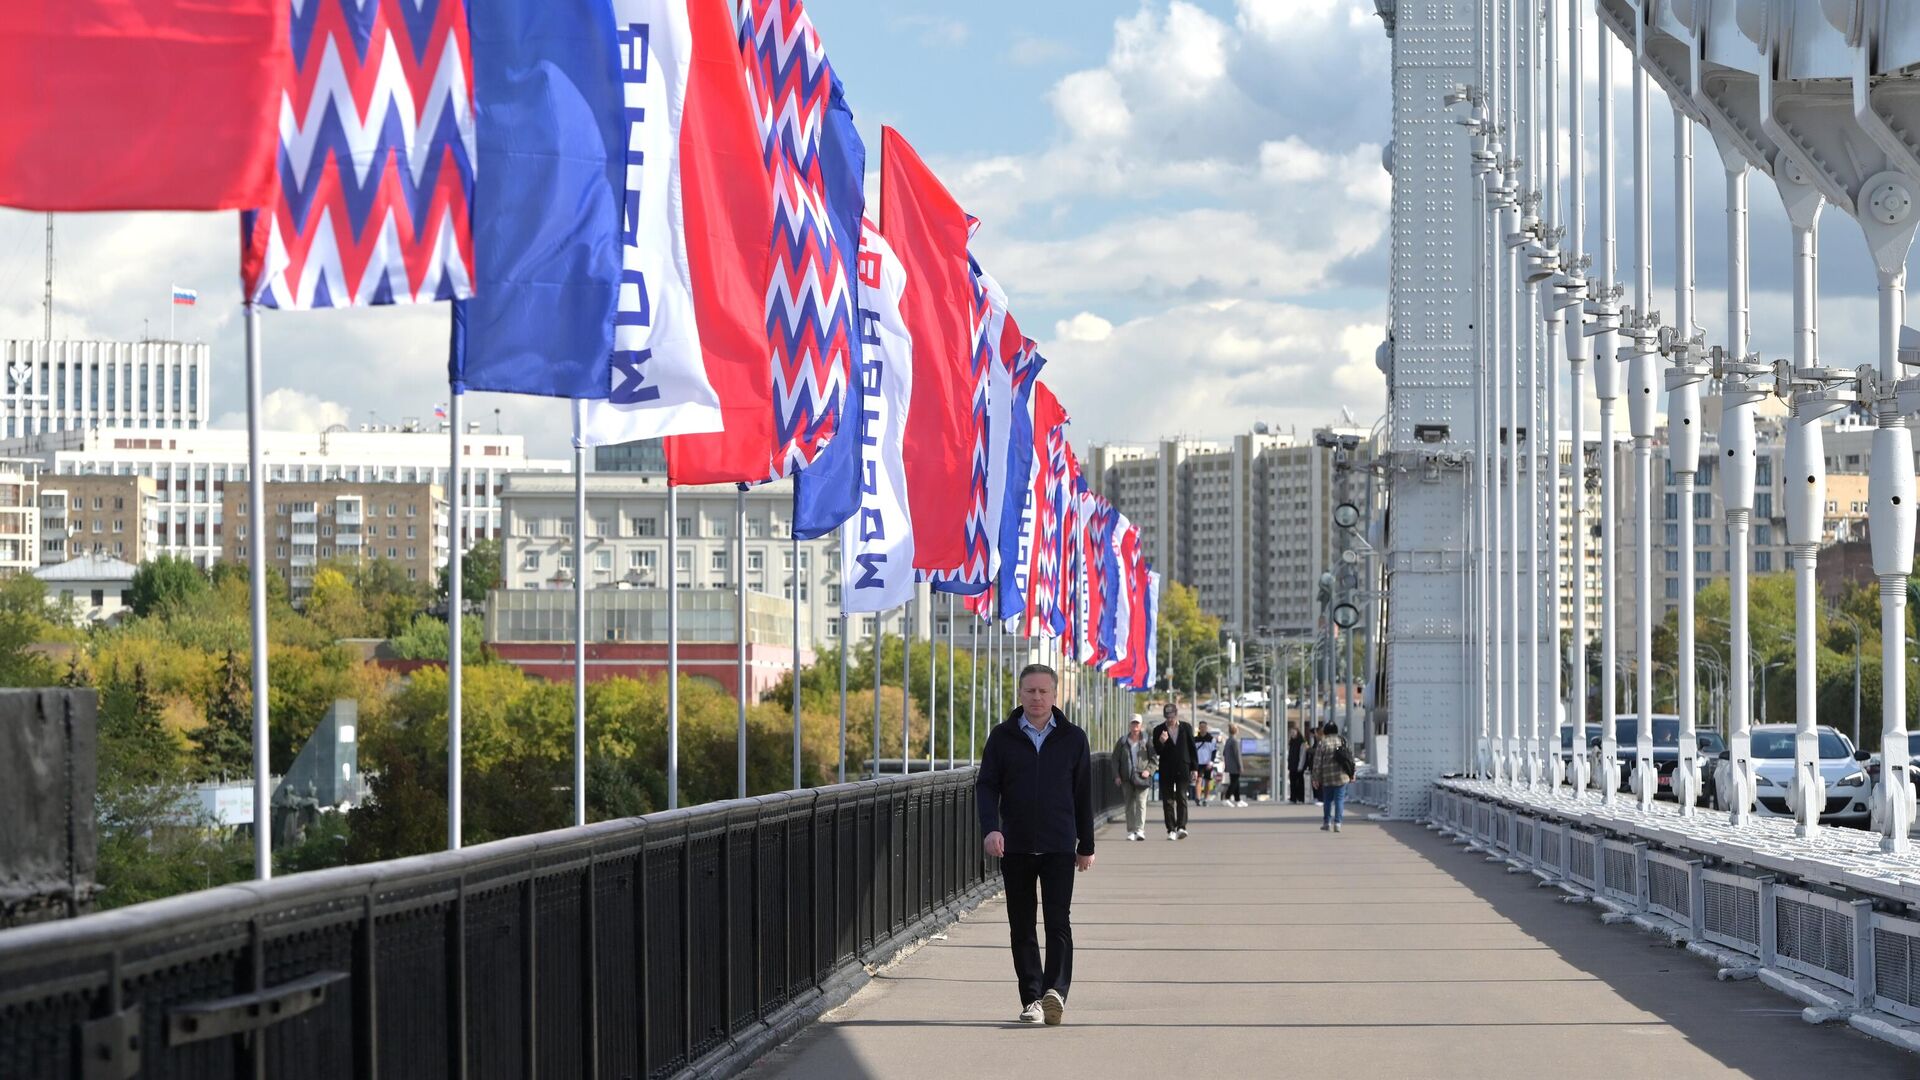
[0,0,1397,457]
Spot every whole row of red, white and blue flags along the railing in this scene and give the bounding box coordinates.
[0,0,1160,690]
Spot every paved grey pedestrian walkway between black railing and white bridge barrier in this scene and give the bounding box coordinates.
[751,805,1920,1080]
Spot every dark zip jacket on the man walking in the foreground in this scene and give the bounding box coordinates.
[975,709,1092,855]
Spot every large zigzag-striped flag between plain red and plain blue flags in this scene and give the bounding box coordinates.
[242,0,476,309]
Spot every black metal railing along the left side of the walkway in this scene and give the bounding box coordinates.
[0,755,1117,1080]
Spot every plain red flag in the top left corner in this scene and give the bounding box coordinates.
[0,0,292,211]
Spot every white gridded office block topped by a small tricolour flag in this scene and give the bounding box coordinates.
[0,338,213,438]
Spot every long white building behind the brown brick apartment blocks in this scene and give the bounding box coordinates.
[0,424,572,565]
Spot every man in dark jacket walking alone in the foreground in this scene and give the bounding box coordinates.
[975,663,1092,1024]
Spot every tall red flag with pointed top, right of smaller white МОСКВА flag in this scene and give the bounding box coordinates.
[879,127,975,571]
